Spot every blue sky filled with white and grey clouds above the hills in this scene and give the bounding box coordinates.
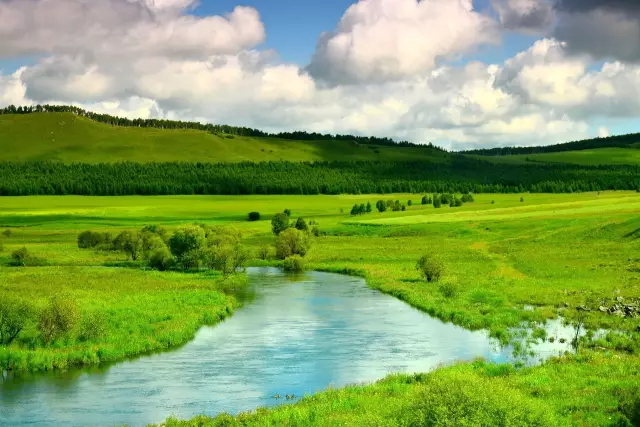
[0,0,640,150]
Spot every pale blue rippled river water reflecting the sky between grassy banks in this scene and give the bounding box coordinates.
[0,269,570,426]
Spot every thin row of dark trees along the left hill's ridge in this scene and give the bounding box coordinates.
[0,105,445,151]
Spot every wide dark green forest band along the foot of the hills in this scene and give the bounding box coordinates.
[0,157,640,196]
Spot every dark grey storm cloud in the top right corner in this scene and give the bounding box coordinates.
[554,0,640,62]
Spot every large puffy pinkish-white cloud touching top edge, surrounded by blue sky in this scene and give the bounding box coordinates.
[308,0,499,84]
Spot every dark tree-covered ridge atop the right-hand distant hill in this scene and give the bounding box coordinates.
[462,133,640,156]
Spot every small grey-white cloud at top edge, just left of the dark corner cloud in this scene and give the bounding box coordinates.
[491,0,555,34]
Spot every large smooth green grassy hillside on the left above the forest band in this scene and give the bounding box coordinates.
[0,113,449,163]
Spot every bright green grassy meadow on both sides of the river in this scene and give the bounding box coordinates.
[0,192,640,425]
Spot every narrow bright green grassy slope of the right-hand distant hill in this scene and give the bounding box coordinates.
[469,148,640,165]
